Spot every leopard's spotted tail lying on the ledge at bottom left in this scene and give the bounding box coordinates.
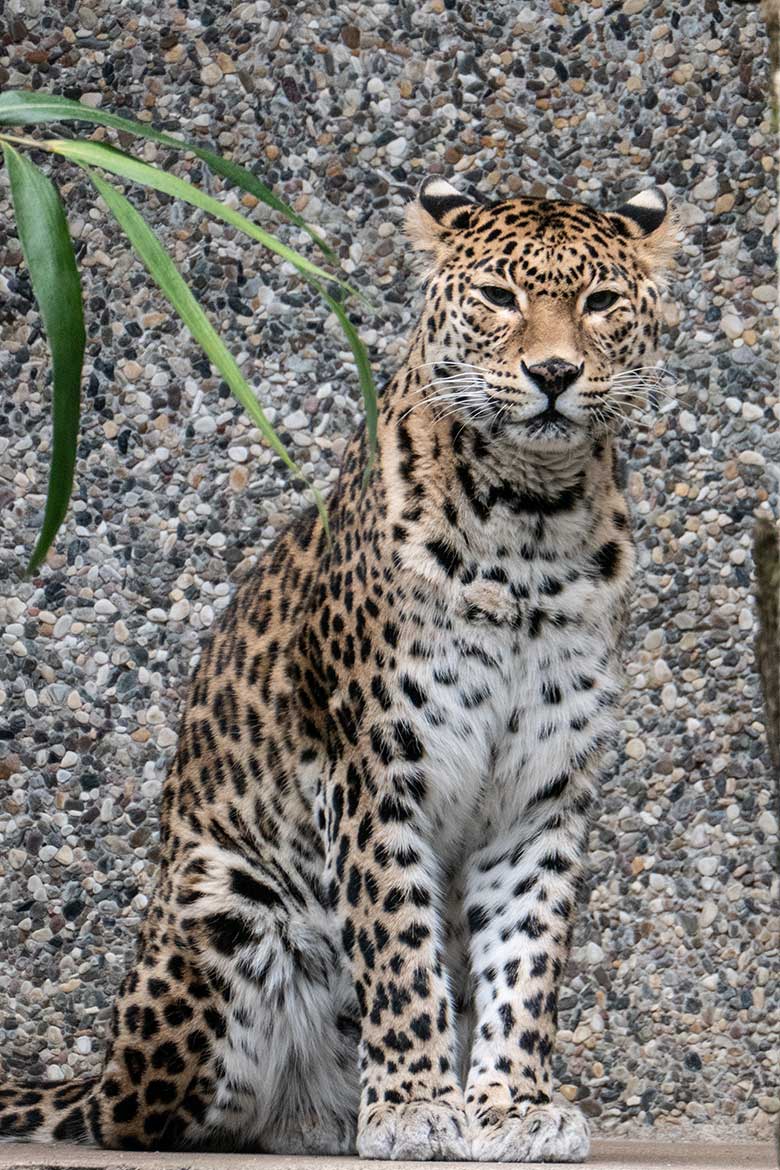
[0,1076,101,1145]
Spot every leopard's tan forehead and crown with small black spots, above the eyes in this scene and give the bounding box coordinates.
[450,198,634,288]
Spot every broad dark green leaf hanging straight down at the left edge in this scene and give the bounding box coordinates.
[2,143,85,573]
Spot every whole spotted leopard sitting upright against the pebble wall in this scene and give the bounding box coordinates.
[0,176,677,1162]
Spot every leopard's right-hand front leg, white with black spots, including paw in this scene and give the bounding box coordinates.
[465,776,591,1162]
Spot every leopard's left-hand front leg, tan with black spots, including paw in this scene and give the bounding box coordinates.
[326,745,469,1162]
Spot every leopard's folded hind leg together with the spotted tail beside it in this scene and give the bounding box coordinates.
[0,842,358,1154]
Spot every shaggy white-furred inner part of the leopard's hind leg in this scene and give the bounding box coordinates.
[162,841,358,1154]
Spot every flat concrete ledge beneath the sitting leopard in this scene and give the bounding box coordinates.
[0,1138,776,1170]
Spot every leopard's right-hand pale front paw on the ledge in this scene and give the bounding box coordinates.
[470,1103,591,1162]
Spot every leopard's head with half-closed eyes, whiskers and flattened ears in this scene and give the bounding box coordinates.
[408,179,676,448]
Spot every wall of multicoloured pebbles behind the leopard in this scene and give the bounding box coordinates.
[0,0,780,1135]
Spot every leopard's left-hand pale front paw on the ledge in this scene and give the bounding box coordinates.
[358,1101,470,1162]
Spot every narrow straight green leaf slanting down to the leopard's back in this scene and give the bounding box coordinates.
[85,167,330,532]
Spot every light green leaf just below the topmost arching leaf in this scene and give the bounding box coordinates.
[46,138,366,301]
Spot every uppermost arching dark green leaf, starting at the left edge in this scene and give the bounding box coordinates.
[0,90,338,264]
